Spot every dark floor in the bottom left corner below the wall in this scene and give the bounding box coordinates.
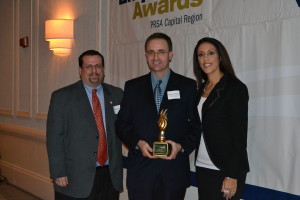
[0,183,41,200]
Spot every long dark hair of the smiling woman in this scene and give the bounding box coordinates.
[193,37,235,84]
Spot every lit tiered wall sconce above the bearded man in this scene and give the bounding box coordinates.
[45,19,74,56]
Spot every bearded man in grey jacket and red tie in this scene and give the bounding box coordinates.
[47,50,123,200]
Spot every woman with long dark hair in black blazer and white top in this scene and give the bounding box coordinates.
[193,37,249,200]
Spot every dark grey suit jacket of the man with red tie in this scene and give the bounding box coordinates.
[47,81,123,198]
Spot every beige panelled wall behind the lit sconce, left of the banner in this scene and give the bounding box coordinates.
[0,0,106,199]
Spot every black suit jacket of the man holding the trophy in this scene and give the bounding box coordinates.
[116,71,201,189]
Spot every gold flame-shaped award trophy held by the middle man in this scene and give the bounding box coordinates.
[153,110,170,156]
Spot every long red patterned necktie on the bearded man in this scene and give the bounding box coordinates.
[92,89,108,166]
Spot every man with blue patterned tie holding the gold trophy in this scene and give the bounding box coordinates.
[116,33,201,200]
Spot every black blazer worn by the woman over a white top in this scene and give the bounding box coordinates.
[196,73,249,178]
